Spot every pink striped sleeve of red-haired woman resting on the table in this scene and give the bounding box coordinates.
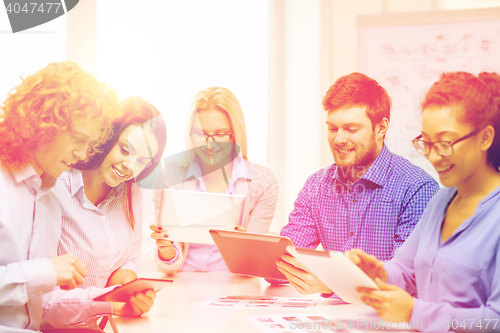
[42,286,116,327]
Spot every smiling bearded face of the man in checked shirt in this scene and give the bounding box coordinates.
[326,106,385,172]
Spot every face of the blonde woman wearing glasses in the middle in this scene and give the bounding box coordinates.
[191,109,234,167]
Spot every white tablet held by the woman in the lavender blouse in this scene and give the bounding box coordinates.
[287,247,379,303]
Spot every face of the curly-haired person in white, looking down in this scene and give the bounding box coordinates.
[31,118,99,178]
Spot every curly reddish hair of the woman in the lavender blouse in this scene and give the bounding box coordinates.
[422,72,500,170]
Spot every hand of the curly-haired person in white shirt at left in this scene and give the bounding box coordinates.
[49,254,87,290]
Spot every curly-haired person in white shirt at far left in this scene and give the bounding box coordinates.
[0,62,118,332]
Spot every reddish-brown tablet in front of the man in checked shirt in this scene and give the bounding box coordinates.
[210,230,293,280]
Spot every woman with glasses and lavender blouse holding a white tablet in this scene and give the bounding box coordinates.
[350,72,500,332]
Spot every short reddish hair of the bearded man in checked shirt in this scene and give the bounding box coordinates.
[323,72,391,128]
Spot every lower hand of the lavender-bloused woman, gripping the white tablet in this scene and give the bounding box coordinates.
[357,278,414,323]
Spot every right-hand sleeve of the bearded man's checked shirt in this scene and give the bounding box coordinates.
[391,179,439,254]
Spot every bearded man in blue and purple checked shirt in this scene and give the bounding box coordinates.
[277,73,439,294]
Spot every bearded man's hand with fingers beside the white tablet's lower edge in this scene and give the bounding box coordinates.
[276,254,332,295]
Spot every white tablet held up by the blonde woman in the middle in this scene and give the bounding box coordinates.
[158,189,245,244]
